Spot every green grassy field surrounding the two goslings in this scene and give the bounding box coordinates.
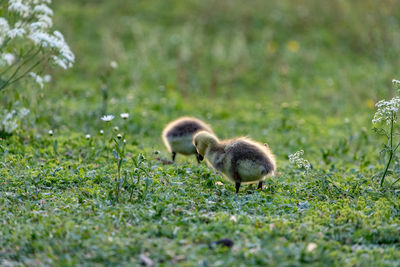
[0,0,400,266]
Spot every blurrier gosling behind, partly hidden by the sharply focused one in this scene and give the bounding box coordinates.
[162,117,213,163]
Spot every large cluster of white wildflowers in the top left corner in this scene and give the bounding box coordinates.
[0,0,75,89]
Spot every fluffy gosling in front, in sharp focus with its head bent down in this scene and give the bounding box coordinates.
[193,131,276,193]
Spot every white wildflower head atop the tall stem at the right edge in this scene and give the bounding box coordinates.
[372,96,400,124]
